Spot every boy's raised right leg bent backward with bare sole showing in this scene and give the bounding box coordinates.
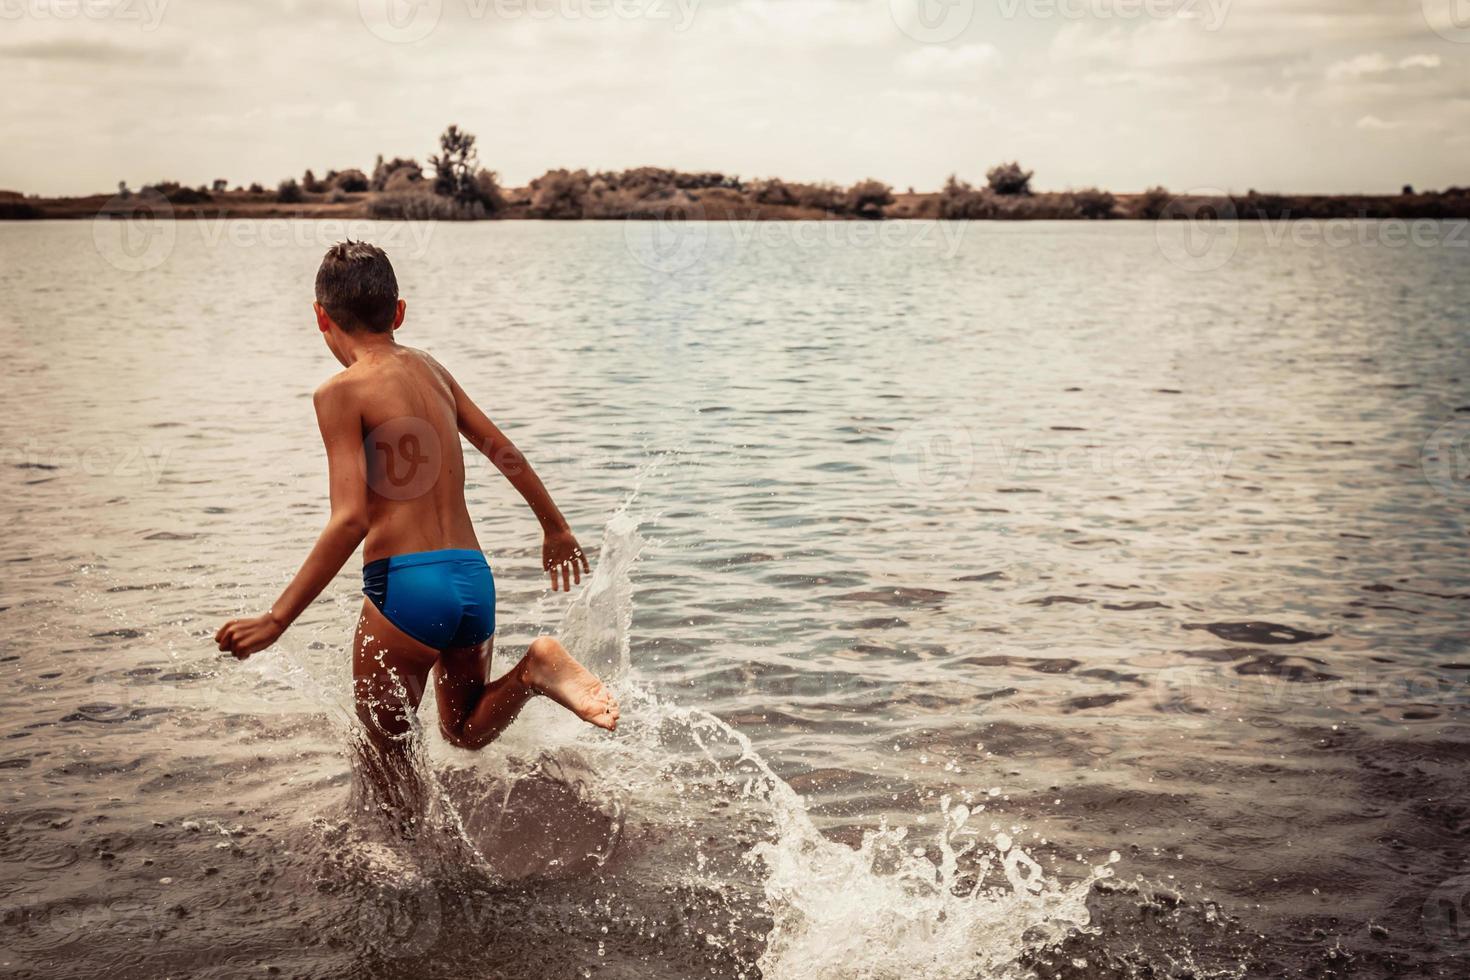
[434,636,617,749]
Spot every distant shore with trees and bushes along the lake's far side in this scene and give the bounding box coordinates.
[0,125,1470,220]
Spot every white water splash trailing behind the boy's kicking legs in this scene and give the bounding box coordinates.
[267,494,1110,980]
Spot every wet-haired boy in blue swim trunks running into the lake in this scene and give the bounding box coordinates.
[215,241,617,768]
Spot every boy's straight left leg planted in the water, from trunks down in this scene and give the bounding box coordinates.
[353,599,438,815]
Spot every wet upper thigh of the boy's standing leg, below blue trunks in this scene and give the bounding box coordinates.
[353,599,440,735]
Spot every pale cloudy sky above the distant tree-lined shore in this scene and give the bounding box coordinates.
[0,0,1470,195]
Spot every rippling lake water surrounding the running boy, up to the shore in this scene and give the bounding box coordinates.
[0,222,1470,980]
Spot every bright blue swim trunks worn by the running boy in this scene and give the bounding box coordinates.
[363,548,495,649]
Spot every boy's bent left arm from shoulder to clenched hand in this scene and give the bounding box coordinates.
[215,382,368,660]
